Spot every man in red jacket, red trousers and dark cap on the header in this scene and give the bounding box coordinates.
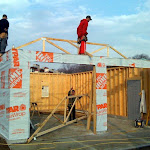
[77,16,92,55]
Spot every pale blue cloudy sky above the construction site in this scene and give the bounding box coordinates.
[0,0,150,57]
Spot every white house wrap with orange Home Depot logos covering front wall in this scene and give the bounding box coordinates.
[0,49,150,141]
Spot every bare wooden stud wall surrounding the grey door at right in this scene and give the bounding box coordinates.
[107,67,150,118]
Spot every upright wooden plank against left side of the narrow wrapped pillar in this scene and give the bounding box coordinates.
[93,66,97,134]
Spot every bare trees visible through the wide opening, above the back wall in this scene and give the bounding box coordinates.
[58,64,93,73]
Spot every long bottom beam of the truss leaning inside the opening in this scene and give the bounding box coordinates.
[36,116,87,137]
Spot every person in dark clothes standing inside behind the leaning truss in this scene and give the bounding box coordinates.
[68,88,76,121]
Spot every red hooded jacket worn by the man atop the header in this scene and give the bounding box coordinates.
[77,19,88,38]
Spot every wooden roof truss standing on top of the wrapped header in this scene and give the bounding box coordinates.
[16,37,127,59]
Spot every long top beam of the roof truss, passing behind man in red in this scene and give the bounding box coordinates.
[45,37,108,46]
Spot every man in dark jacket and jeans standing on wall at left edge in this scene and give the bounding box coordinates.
[0,14,9,56]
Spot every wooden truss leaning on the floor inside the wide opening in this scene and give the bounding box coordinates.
[27,94,92,143]
